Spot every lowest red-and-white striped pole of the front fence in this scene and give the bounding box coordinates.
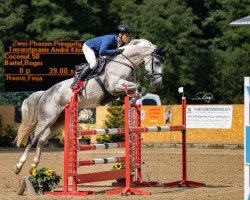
[78,157,125,166]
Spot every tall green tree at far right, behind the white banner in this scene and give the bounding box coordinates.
[203,0,250,103]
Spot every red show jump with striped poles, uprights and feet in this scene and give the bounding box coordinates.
[45,82,205,196]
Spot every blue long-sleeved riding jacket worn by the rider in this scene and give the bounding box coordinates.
[85,34,123,56]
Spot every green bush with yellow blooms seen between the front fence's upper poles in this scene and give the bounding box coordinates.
[96,106,124,144]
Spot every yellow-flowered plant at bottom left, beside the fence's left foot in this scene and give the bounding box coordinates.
[29,167,61,192]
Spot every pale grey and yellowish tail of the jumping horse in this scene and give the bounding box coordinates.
[15,91,44,147]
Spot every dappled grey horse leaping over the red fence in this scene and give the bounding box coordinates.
[14,39,166,174]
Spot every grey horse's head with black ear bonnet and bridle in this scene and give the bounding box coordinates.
[144,47,167,87]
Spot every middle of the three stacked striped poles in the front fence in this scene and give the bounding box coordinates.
[79,142,125,151]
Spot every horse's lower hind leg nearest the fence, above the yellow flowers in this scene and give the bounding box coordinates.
[29,128,51,173]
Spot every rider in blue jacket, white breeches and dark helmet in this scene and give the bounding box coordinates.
[70,25,132,88]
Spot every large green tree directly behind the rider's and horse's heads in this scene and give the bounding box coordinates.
[114,0,201,103]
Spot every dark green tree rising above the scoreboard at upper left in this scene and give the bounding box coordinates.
[0,0,78,94]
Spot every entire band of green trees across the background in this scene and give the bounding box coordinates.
[0,0,250,104]
